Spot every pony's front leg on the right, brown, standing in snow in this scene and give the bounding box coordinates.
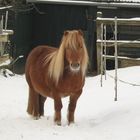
[67,90,82,125]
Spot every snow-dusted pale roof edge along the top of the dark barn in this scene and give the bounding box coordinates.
[26,0,140,8]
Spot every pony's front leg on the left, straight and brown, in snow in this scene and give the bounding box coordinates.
[54,97,62,125]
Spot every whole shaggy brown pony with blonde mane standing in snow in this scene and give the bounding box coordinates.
[25,30,88,125]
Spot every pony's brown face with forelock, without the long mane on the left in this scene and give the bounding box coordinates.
[62,30,88,74]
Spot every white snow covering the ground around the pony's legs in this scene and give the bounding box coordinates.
[0,66,140,140]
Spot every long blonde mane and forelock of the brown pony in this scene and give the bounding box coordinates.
[45,30,88,84]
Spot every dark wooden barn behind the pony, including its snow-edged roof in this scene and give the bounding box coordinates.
[5,0,140,73]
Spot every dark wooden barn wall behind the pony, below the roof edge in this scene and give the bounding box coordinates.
[10,4,140,73]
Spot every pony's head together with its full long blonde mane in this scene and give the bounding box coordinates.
[49,30,88,83]
